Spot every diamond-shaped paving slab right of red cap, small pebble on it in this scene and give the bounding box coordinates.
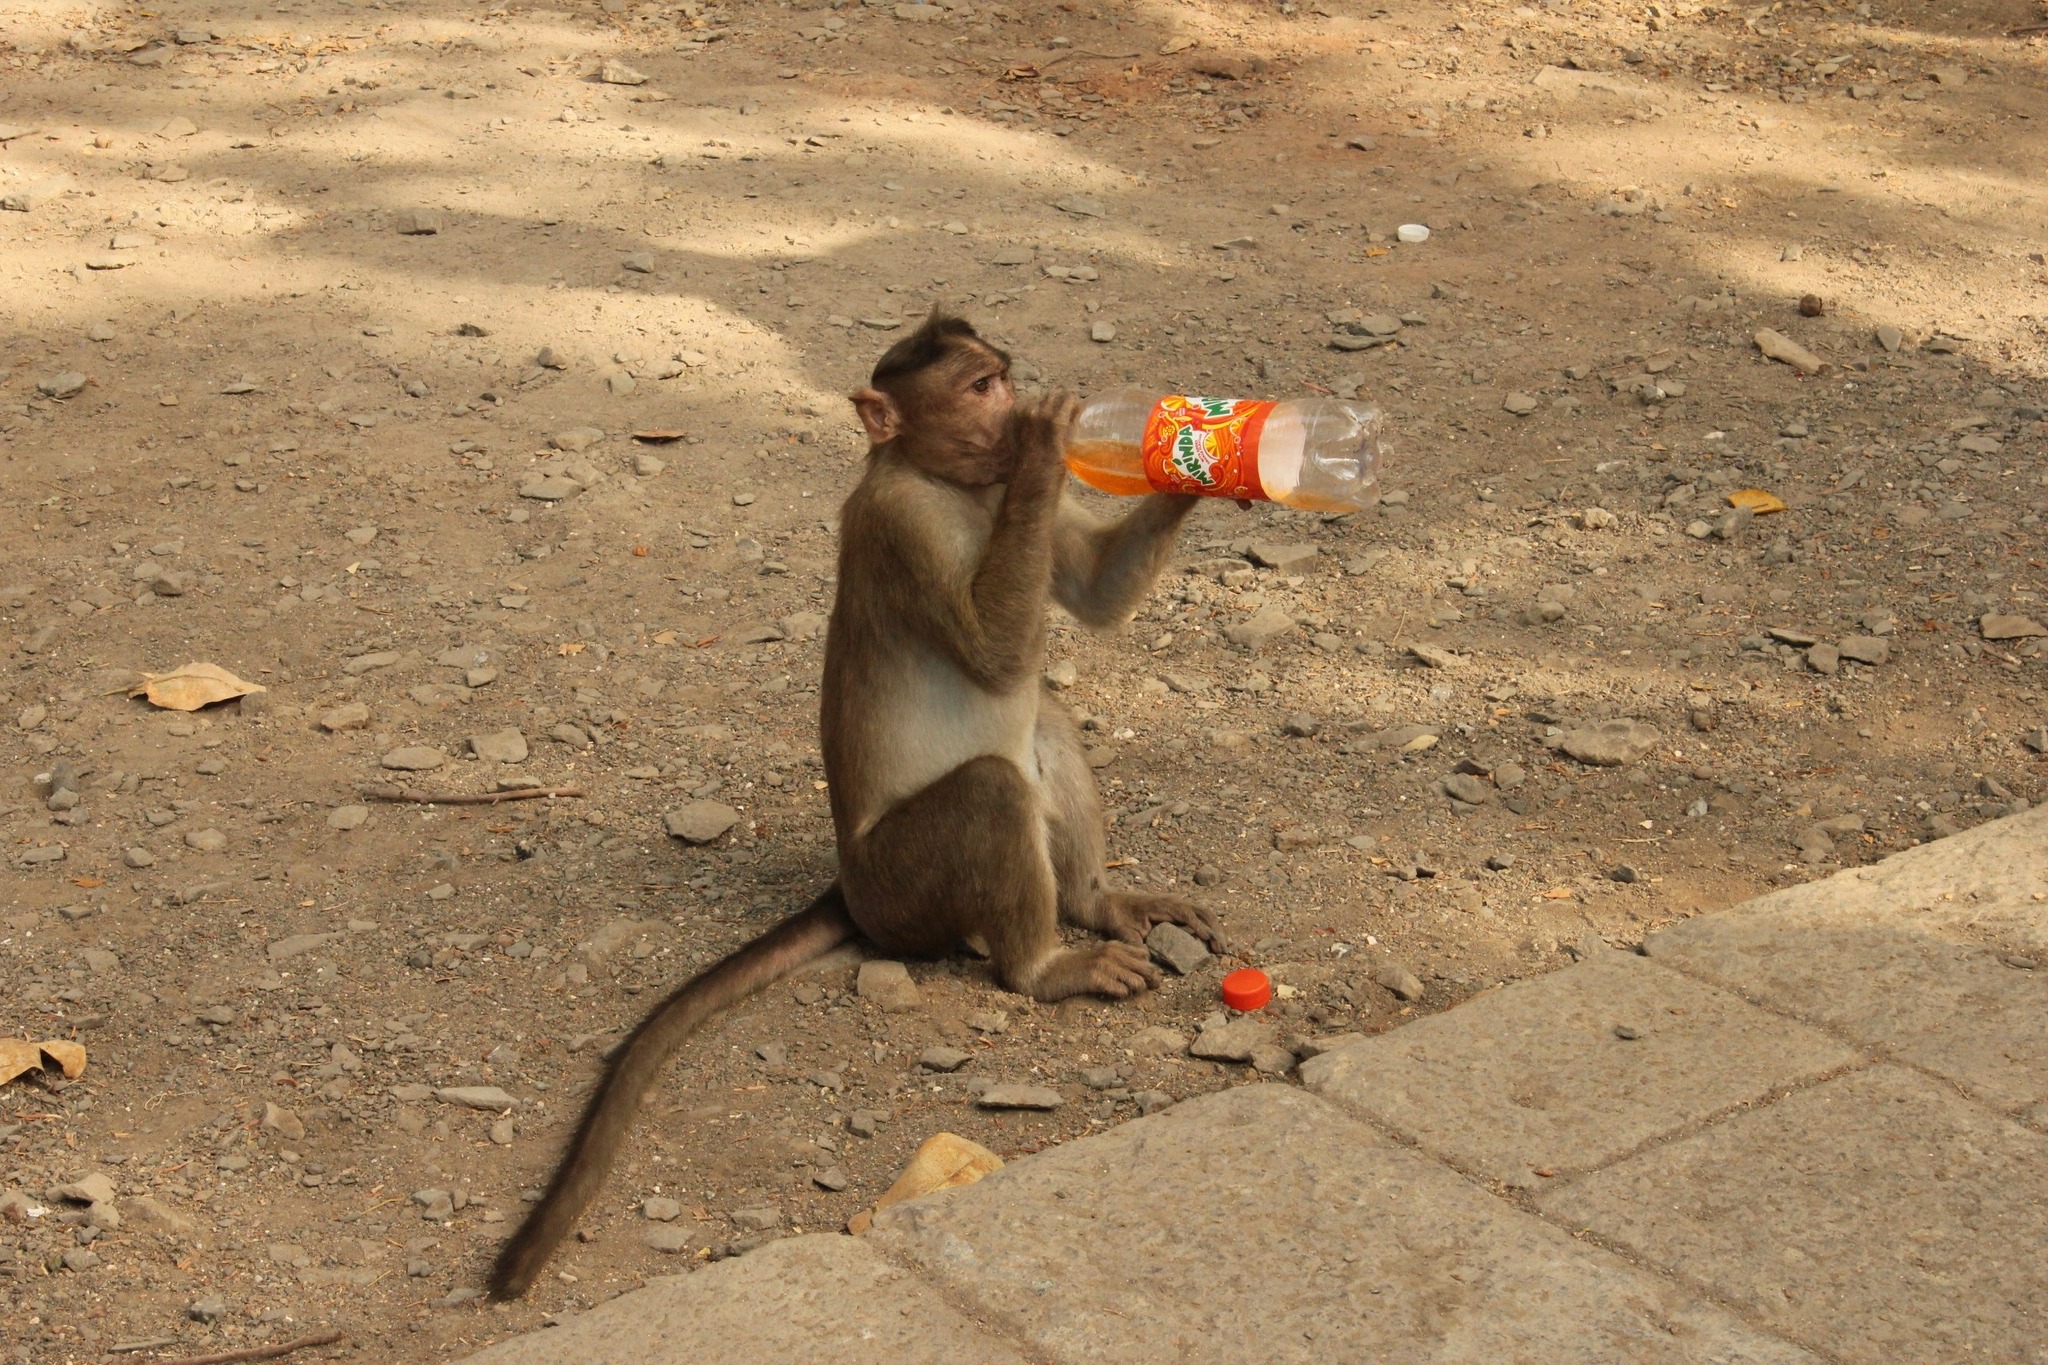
[1300,952,1858,1185]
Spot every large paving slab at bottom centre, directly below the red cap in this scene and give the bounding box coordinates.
[864,1085,1810,1365]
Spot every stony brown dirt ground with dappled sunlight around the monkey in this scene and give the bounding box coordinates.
[0,0,2048,1363]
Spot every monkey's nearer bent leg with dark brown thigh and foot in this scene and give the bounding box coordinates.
[840,757,1159,1001]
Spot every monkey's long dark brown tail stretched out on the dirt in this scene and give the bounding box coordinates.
[489,882,858,1300]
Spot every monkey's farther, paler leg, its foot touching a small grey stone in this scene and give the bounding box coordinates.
[1032,702,1223,945]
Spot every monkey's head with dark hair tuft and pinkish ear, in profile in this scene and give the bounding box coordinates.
[852,309,1018,487]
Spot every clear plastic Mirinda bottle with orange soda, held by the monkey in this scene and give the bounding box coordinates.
[1067,389,1386,512]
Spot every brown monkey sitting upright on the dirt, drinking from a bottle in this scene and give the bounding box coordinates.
[489,313,1217,1300]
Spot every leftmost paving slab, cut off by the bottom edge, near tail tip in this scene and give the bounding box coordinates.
[469,1234,1024,1365]
